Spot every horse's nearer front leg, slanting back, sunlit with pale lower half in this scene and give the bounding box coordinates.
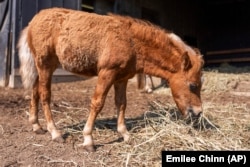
[83,70,115,152]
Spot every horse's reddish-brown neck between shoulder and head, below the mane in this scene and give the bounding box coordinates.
[135,27,182,79]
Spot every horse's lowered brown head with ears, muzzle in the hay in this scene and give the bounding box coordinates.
[169,50,204,117]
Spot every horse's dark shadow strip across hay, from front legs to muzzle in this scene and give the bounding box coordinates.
[63,102,219,141]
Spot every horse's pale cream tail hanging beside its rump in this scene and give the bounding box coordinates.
[17,27,38,89]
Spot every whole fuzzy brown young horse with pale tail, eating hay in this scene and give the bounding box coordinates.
[18,8,203,151]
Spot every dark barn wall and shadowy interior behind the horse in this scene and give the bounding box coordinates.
[0,0,250,87]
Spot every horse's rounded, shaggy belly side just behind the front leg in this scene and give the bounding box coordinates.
[56,33,98,76]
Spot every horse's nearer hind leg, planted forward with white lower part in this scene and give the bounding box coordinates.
[38,66,64,142]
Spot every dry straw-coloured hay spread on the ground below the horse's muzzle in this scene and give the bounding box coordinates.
[58,101,250,166]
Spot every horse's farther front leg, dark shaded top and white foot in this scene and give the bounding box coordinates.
[114,80,129,142]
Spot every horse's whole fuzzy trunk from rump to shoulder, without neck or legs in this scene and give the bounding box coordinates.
[25,8,135,76]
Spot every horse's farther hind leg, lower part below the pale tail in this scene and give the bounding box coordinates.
[29,77,45,134]
